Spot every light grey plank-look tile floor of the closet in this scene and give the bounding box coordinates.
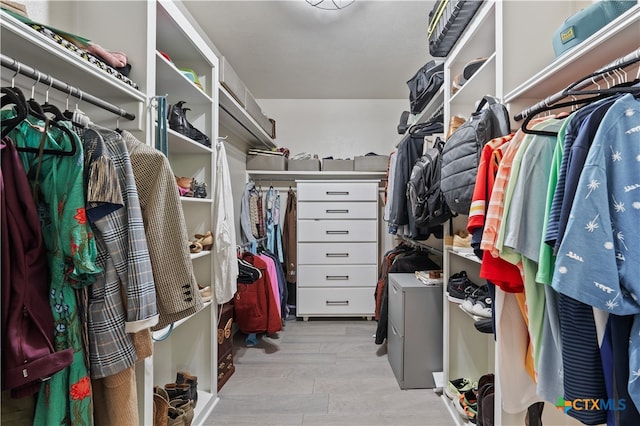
[204,318,455,426]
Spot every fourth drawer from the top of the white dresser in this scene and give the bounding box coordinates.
[298,242,378,265]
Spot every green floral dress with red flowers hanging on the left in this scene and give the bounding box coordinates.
[3,111,100,425]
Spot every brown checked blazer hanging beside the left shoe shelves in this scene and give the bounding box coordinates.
[122,131,203,330]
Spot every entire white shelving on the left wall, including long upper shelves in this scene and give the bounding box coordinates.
[0,0,275,424]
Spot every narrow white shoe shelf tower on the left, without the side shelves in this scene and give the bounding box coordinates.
[150,1,218,424]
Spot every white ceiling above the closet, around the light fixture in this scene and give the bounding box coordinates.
[183,0,434,99]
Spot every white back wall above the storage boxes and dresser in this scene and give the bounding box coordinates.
[258,99,409,158]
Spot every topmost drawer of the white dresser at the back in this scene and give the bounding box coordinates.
[297,182,378,201]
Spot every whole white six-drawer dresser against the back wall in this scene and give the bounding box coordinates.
[296,180,379,320]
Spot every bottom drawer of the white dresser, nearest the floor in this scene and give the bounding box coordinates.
[296,287,375,315]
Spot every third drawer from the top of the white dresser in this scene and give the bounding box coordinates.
[298,219,378,242]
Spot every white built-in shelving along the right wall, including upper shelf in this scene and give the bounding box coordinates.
[442,0,640,425]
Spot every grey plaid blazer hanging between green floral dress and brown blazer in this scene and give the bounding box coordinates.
[82,125,158,379]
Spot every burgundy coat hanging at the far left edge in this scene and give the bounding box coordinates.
[0,138,73,397]
